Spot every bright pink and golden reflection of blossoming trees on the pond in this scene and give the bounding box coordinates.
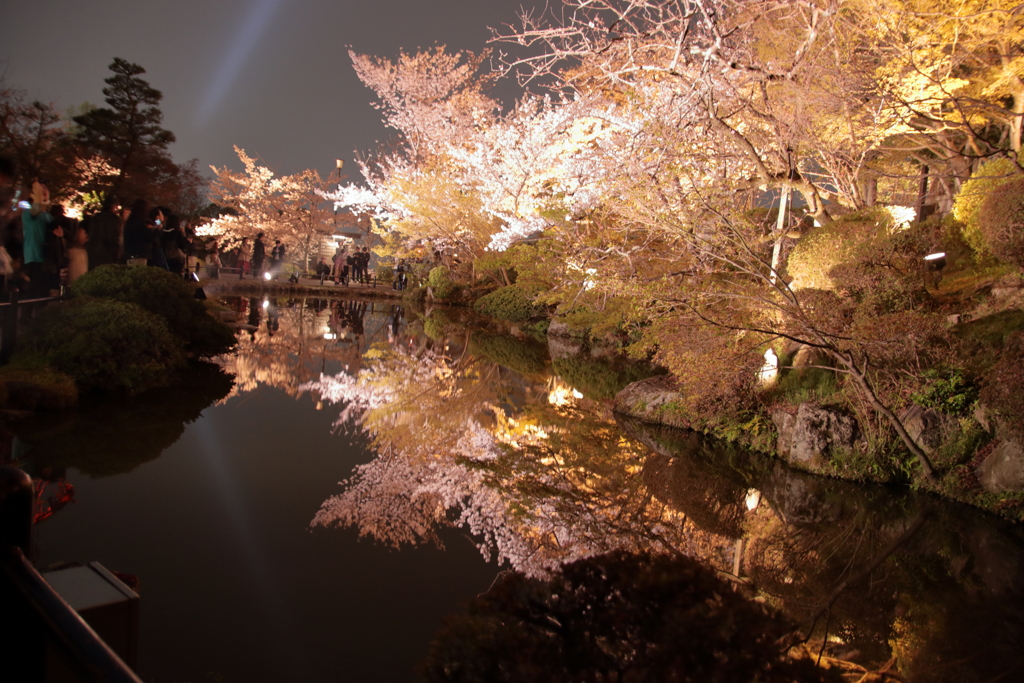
[304,335,724,575]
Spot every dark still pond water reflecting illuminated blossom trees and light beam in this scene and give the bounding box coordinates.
[14,298,1024,682]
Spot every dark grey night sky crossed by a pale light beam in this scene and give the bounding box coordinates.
[0,0,543,175]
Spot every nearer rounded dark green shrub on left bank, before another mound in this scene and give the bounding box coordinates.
[13,297,185,393]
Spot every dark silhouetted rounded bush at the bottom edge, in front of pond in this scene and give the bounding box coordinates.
[421,551,842,683]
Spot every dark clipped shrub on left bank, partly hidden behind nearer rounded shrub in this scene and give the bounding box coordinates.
[71,265,234,357]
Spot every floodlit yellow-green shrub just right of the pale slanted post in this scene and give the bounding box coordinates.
[786,209,893,290]
